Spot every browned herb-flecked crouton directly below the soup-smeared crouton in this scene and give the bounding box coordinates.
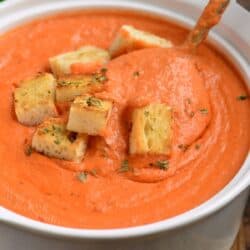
[56,73,106,102]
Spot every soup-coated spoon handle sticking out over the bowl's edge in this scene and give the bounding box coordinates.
[184,0,230,49]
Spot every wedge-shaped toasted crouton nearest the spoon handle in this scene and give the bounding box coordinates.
[109,25,173,57]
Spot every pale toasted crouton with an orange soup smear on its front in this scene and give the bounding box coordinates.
[49,46,110,76]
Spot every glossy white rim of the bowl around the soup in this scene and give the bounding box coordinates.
[0,0,250,240]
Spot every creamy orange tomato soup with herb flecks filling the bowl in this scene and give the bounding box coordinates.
[0,11,250,228]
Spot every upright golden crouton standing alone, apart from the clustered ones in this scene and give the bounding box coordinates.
[129,104,172,155]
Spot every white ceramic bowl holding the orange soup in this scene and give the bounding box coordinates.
[0,0,250,250]
